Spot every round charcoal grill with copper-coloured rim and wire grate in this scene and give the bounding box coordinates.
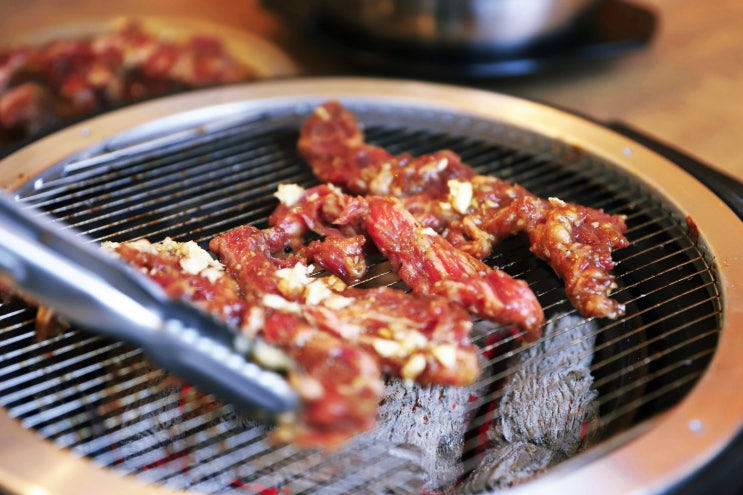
[0,78,743,495]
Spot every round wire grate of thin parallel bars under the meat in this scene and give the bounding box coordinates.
[0,104,721,494]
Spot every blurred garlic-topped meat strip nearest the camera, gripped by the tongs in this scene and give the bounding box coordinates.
[105,239,384,447]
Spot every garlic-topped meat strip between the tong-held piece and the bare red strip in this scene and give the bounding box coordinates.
[210,225,479,385]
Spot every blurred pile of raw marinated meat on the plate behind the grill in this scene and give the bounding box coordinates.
[0,21,255,141]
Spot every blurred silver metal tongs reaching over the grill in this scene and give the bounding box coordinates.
[0,193,297,415]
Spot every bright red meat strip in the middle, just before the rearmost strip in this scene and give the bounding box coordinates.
[269,185,544,340]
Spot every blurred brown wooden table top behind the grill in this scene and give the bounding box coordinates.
[0,0,743,179]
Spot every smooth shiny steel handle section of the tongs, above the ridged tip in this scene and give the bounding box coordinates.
[0,196,165,338]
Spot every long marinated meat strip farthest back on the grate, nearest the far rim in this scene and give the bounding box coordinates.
[298,101,629,318]
